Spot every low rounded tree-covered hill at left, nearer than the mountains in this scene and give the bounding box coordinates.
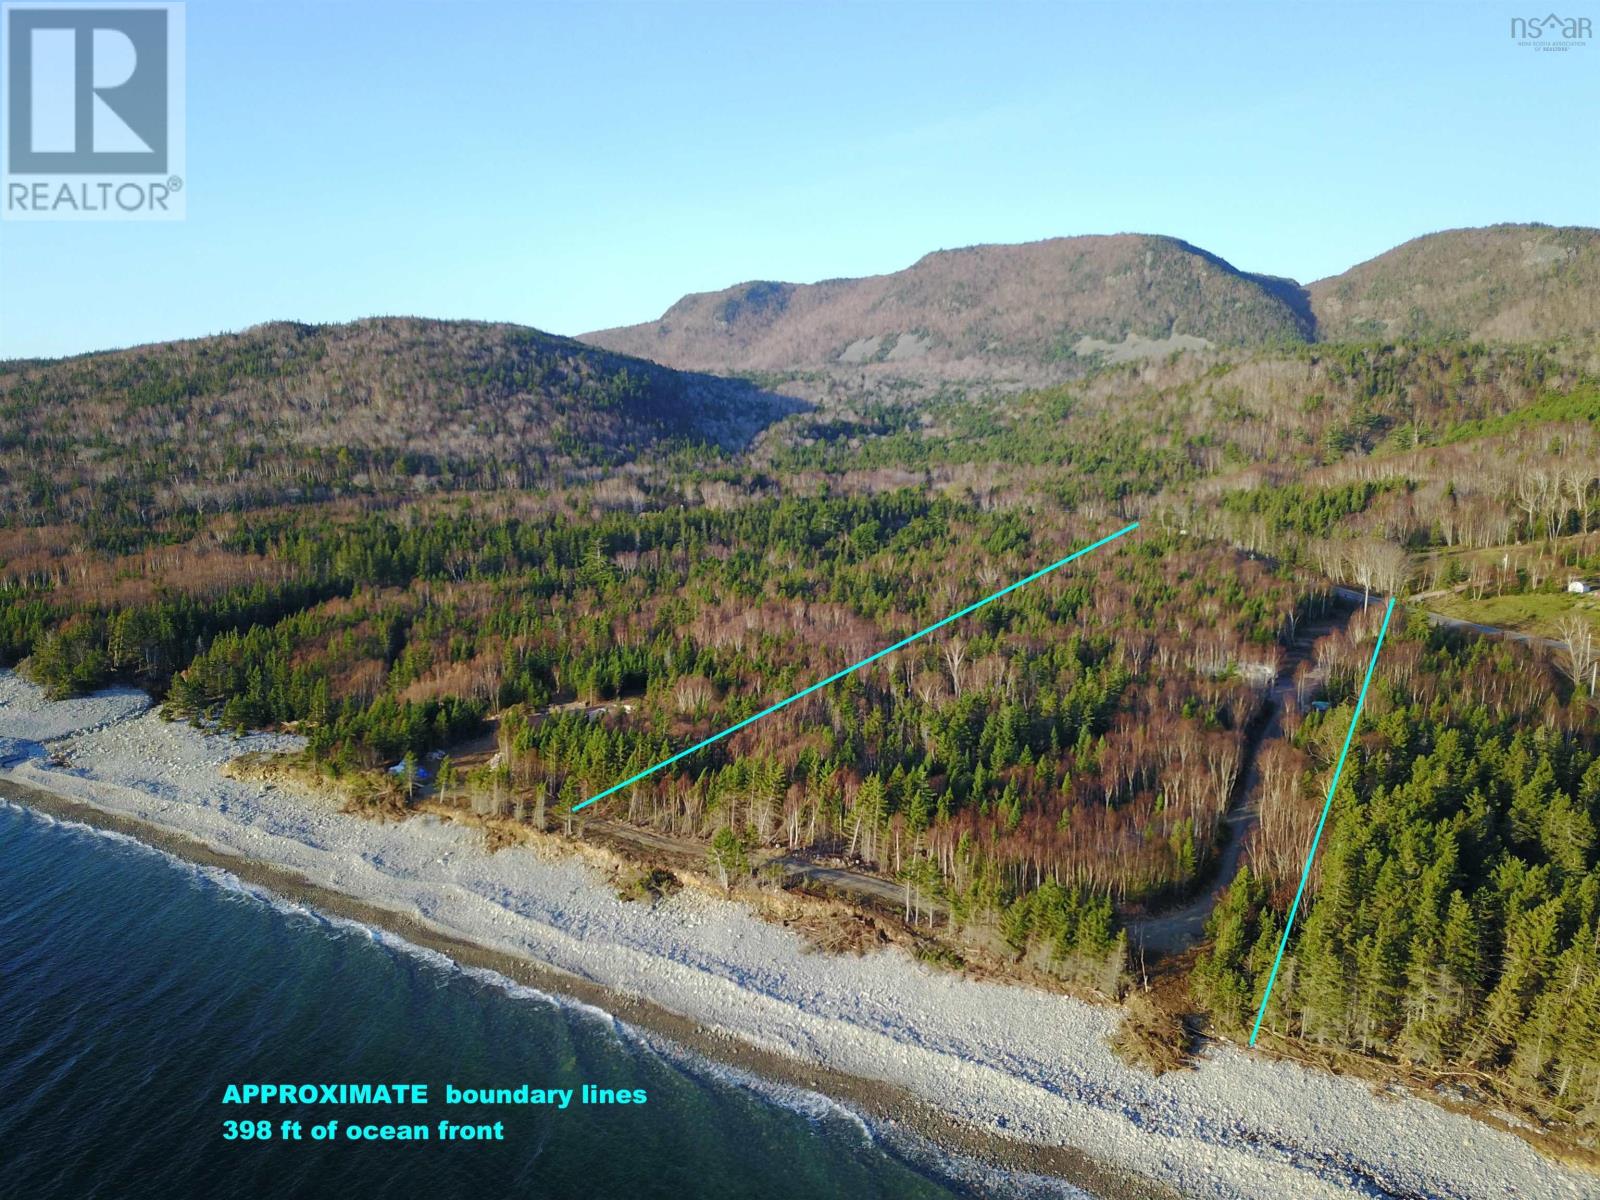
[0,318,795,531]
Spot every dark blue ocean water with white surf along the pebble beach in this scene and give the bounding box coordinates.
[0,802,1072,1200]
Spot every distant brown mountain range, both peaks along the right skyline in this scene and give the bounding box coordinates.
[579,224,1600,373]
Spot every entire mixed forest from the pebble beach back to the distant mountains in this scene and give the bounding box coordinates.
[0,320,1600,1130]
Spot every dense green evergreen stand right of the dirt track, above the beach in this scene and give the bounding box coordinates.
[1194,616,1600,1126]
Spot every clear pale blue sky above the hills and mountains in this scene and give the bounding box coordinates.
[0,0,1600,357]
